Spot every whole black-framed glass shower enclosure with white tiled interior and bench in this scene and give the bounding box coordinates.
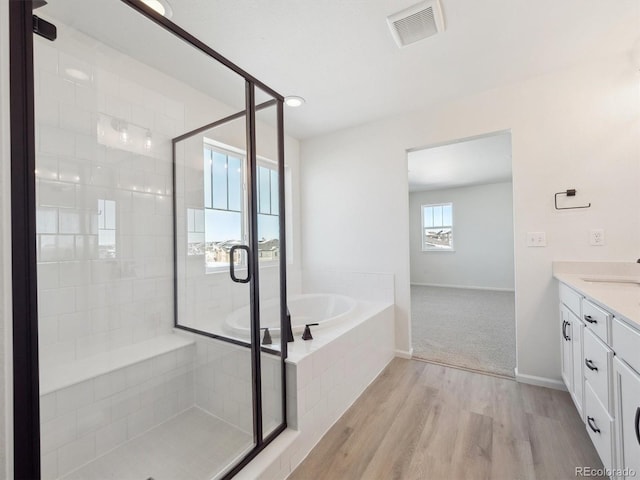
[11,0,287,479]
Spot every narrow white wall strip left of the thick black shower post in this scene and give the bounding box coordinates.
[0,0,13,478]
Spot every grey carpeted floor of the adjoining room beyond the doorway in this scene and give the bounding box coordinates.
[411,285,516,376]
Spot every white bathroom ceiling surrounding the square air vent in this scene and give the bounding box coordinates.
[42,0,640,138]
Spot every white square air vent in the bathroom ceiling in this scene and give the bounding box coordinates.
[387,0,444,47]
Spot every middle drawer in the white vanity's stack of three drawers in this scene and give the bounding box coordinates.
[583,328,613,412]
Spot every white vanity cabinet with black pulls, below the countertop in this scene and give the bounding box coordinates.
[559,283,640,480]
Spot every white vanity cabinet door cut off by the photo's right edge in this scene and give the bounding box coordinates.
[614,358,640,479]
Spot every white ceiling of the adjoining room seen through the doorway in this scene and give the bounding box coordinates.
[408,133,511,192]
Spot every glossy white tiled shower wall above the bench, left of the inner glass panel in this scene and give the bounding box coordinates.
[34,36,179,366]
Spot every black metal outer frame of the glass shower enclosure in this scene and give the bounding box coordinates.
[9,0,287,480]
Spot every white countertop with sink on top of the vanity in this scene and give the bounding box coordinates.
[553,262,640,329]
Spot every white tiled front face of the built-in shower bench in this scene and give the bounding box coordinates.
[40,344,196,479]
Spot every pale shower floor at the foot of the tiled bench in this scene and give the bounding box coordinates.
[63,408,253,480]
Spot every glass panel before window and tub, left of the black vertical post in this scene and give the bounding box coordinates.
[178,114,252,346]
